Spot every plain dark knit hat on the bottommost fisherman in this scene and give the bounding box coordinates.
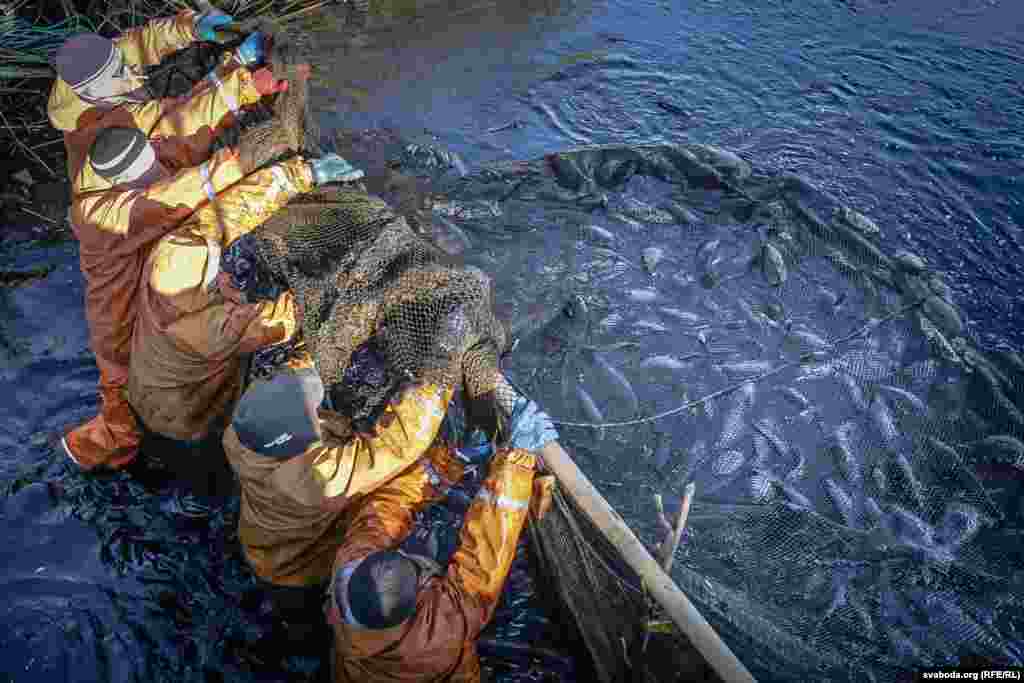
[335,550,418,629]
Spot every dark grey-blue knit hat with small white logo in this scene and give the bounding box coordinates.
[231,368,324,459]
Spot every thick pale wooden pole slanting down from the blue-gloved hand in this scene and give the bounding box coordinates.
[540,441,755,683]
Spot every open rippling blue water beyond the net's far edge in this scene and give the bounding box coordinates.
[322,0,1024,345]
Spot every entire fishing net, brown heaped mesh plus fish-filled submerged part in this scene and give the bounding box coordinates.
[190,21,1024,681]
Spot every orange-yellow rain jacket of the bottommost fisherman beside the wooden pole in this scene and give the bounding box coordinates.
[328,450,553,683]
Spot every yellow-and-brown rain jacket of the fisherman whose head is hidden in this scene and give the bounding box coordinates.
[128,157,312,440]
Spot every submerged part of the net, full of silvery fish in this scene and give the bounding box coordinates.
[409,137,1024,681]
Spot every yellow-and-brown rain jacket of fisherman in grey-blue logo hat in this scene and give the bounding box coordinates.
[224,374,462,586]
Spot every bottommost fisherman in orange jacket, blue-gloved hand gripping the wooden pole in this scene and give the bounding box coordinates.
[326,397,558,683]
